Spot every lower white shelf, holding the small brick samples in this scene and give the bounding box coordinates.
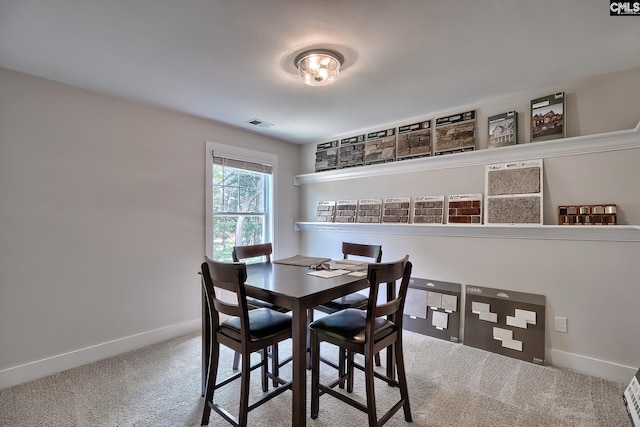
[294,222,640,242]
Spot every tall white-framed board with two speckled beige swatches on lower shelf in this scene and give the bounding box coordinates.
[484,160,543,224]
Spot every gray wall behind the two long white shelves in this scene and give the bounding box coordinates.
[301,68,640,381]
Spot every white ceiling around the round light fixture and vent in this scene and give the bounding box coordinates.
[0,0,640,143]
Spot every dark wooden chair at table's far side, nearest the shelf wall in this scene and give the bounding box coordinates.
[309,242,382,378]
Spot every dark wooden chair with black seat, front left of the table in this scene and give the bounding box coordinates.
[201,256,292,427]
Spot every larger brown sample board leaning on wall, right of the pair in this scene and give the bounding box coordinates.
[464,285,546,365]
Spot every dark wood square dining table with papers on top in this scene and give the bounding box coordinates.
[202,263,369,427]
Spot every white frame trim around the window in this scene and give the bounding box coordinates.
[204,141,278,257]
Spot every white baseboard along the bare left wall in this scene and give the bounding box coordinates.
[0,318,202,390]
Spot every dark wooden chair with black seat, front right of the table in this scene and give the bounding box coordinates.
[309,255,412,427]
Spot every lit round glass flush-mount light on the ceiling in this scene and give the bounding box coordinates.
[293,49,344,86]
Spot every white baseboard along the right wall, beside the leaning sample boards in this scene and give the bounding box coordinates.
[547,349,638,384]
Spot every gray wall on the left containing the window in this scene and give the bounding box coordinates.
[0,69,300,388]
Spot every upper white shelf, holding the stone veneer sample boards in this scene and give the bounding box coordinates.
[293,123,640,185]
